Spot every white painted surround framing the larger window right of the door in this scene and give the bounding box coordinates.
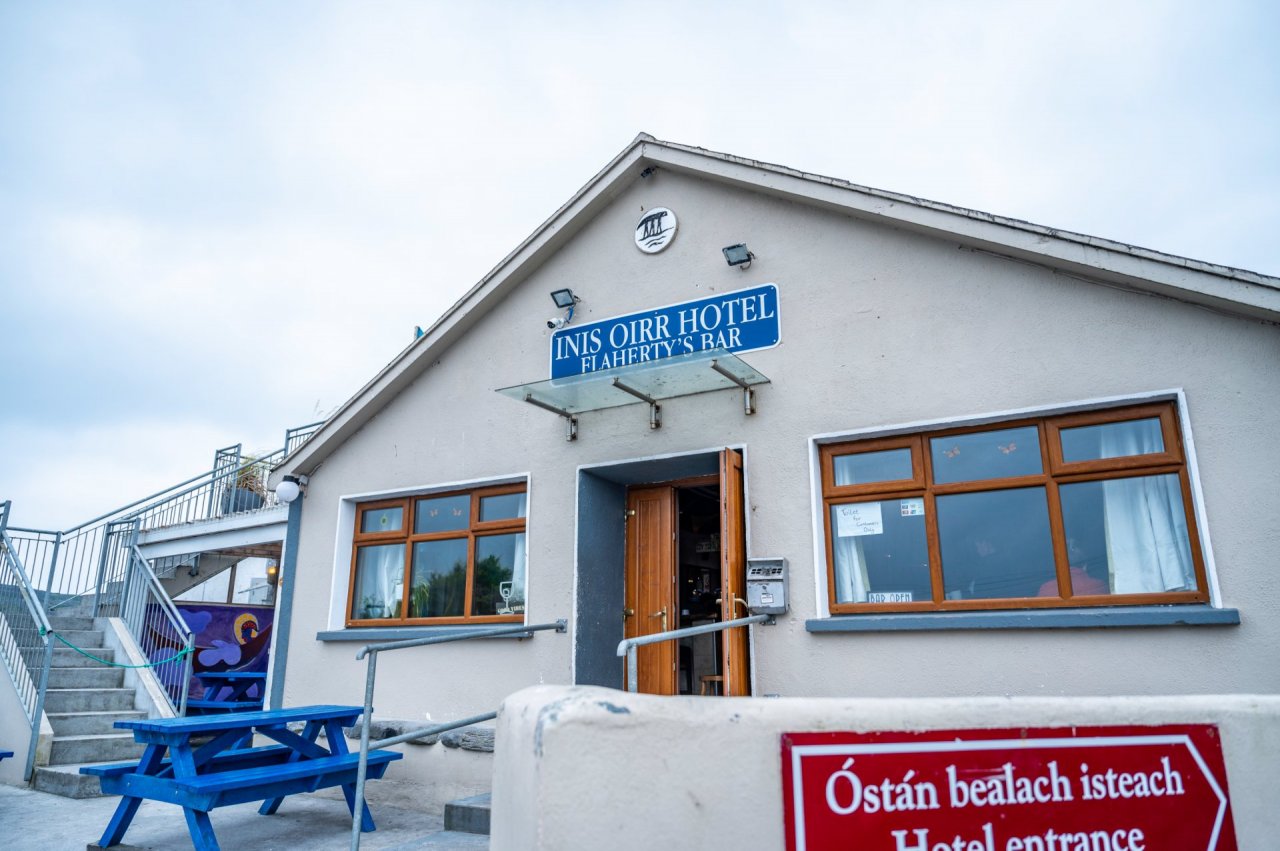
[809,388,1221,618]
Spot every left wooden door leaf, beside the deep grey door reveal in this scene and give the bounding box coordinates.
[622,485,680,695]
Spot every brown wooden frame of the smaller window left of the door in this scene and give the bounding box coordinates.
[344,482,529,627]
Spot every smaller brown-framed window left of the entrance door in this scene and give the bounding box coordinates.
[347,485,527,626]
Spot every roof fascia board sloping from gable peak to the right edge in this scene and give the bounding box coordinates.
[645,142,1280,322]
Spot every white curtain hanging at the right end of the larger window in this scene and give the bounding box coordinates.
[1101,426,1196,594]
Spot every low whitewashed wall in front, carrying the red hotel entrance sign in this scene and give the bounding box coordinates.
[492,686,1280,851]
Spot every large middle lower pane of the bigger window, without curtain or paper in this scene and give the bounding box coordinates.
[937,488,1057,600]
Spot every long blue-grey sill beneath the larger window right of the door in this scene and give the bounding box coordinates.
[804,605,1240,632]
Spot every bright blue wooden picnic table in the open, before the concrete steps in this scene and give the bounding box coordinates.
[81,706,403,851]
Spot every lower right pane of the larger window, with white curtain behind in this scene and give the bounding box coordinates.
[1059,473,1196,594]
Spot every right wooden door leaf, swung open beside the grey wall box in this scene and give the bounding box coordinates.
[719,449,751,697]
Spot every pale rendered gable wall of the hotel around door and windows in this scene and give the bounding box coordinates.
[277,171,1280,798]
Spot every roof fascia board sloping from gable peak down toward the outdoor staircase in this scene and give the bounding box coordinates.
[270,133,653,473]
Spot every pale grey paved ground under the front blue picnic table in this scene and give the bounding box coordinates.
[0,783,489,851]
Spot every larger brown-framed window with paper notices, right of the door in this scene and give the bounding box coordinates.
[820,403,1208,614]
